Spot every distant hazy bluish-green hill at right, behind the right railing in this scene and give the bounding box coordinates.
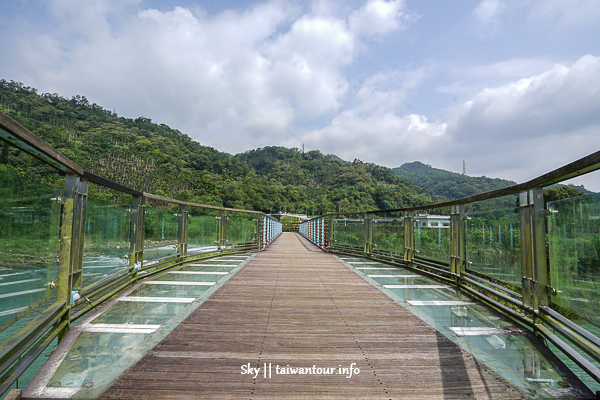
[393,161,516,200]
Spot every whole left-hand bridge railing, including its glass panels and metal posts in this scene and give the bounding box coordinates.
[0,112,281,396]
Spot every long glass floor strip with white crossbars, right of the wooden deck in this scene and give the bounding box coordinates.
[342,259,596,399]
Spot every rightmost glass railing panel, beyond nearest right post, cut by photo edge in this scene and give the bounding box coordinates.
[547,194,600,327]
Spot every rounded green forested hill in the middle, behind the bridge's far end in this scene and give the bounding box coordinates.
[235,147,435,211]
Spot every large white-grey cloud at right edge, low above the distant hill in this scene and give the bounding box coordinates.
[446,55,600,181]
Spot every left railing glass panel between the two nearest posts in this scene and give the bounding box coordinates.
[83,190,131,284]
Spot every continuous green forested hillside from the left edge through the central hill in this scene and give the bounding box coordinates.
[0,80,435,214]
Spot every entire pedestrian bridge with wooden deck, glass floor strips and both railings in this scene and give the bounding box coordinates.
[0,110,600,399]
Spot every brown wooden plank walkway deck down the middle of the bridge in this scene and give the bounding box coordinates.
[96,233,526,400]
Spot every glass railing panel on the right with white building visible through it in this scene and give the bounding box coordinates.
[414,208,451,264]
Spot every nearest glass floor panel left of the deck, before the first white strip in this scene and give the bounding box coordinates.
[47,332,148,388]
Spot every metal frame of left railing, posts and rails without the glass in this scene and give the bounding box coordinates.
[0,112,281,396]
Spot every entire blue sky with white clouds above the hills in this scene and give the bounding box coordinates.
[0,0,600,191]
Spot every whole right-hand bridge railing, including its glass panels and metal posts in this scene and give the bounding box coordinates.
[299,148,600,390]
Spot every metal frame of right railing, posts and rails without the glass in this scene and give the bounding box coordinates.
[299,151,600,383]
